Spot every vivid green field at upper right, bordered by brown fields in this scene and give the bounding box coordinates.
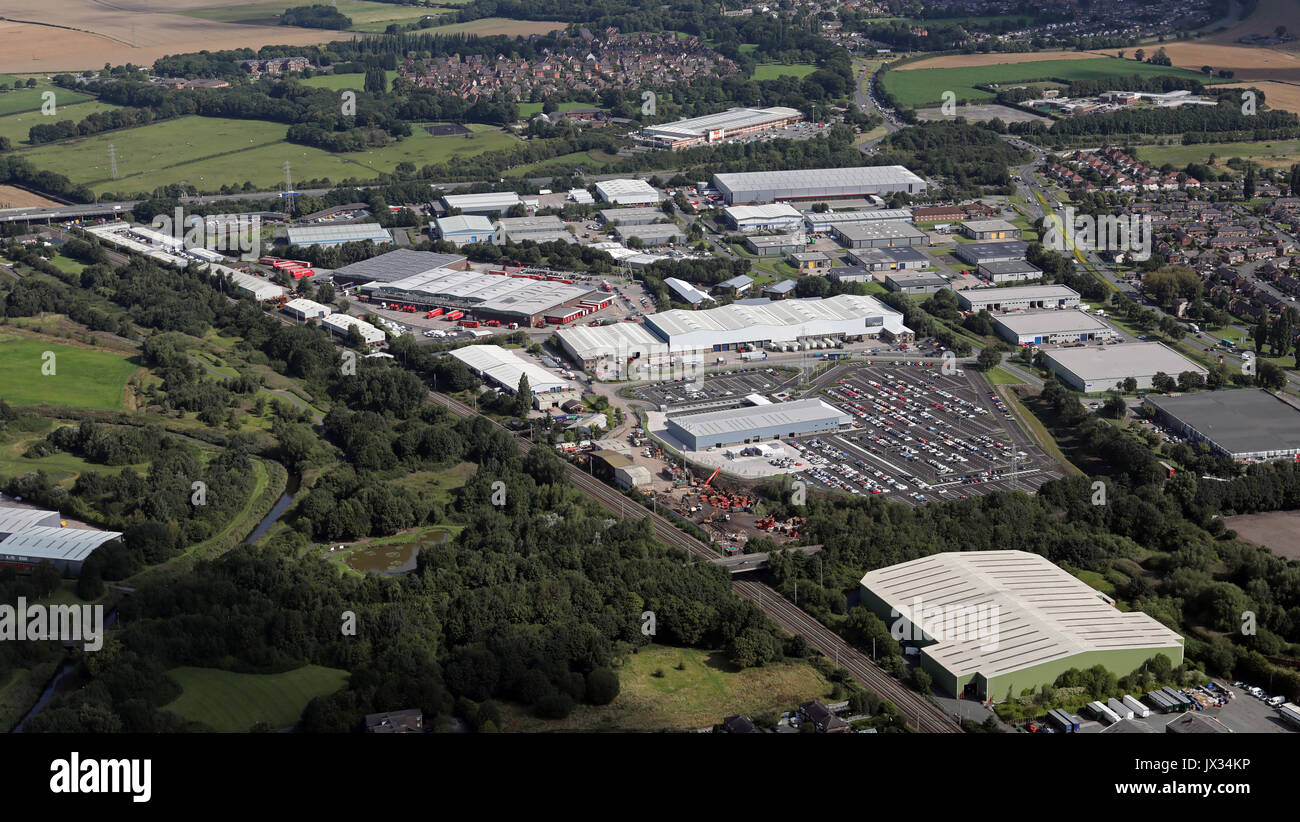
[884,57,1227,105]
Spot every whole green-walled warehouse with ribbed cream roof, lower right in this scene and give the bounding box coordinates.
[862,550,1183,700]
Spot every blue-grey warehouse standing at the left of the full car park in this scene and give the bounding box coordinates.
[668,399,853,451]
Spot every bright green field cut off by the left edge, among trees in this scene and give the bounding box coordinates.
[0,334,137,411]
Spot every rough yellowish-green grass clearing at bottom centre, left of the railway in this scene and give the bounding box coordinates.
[502,645,829,731]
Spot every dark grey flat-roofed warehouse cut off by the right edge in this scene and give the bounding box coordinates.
[1145,392,1300,462]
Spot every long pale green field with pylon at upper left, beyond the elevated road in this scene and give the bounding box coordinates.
[20,117,516,192]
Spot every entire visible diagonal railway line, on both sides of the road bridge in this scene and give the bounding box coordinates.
[429,391,962,734]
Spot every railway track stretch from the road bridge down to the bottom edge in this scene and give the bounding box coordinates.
[732,580,962,734]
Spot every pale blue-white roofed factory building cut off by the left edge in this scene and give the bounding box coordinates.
[0,503,122,576]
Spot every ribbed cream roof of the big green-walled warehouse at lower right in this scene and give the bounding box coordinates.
[862,550,1183,678]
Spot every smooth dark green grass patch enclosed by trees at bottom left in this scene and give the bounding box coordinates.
[164,665,347,734]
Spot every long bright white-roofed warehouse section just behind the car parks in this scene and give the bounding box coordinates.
[645,294,914,351]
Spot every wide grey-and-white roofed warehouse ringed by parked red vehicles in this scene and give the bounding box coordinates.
[361,268,597,325]
